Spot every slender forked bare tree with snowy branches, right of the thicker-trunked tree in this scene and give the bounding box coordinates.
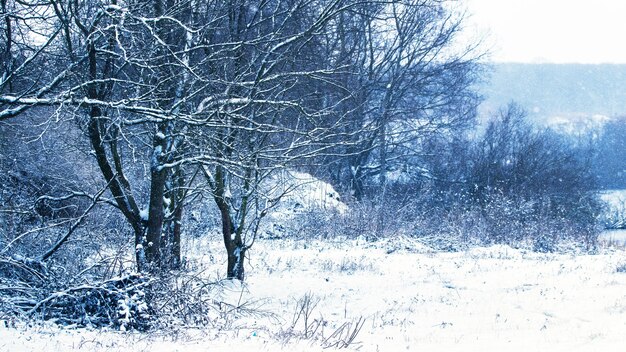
[193,0,364,280]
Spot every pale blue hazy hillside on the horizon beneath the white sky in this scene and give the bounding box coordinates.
[479,63,626,122]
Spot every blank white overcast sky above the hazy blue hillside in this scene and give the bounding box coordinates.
[466,0,626,63]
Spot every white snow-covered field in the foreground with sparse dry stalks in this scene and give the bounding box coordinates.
[0,238,626,352]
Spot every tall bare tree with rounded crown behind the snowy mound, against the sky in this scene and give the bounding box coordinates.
[316,1,481,199]
